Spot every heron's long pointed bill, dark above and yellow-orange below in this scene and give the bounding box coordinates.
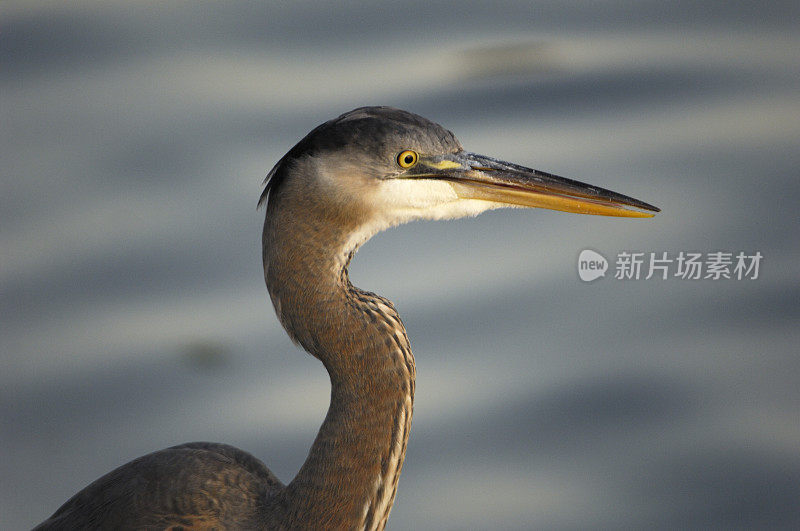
[406,151,660,218]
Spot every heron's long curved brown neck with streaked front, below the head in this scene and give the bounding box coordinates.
[264,200,415,529]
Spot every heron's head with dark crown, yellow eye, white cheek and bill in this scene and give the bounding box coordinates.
[262,107,659,243]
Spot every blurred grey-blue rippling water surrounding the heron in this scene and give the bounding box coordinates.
[0,0,800,529]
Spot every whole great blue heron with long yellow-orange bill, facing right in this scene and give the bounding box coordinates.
[37,107,659,529]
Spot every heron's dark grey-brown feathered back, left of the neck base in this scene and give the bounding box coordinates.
[35,443,283,530]
